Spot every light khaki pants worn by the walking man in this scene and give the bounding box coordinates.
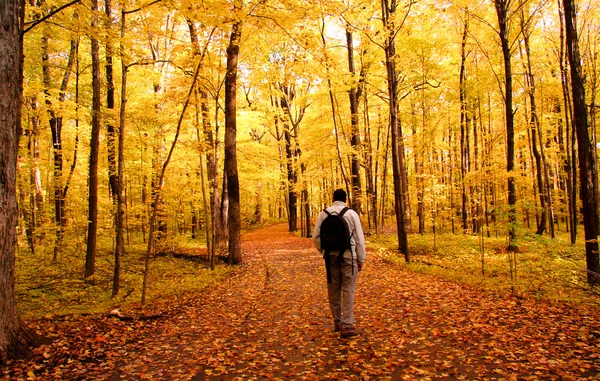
[327,250,358,325]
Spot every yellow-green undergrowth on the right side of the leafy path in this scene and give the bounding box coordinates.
[371,227,600,304]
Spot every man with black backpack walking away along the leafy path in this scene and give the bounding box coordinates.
[313,189,366,338]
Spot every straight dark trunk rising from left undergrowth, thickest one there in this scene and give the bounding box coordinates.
[85,0,101,279]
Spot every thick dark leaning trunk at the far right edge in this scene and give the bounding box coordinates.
[564,0,600,285]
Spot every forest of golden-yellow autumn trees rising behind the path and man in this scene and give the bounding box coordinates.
[0,0,600,372]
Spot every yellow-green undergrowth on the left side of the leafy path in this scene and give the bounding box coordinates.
[15,237,230,320]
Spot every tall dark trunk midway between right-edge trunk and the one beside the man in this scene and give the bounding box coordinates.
[494,0,518,251]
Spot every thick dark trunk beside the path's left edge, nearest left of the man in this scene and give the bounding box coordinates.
[225,15,242,265]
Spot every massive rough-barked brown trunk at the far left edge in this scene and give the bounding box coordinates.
[0,0,29,364]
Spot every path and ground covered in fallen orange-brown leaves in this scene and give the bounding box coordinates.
[0,225,600,381]
